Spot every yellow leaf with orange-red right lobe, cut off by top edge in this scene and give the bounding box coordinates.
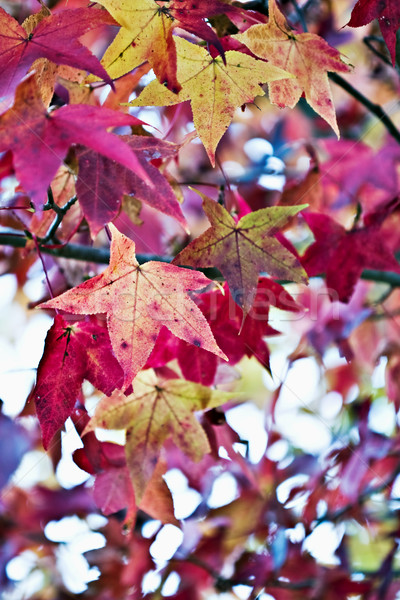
[96,0,180,92]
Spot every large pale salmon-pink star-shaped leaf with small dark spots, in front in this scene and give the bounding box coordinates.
[40,225,226,387]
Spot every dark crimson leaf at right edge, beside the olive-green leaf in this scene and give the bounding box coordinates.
[301,213,400,302]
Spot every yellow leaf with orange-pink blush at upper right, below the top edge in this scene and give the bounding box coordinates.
[232,0,349,137]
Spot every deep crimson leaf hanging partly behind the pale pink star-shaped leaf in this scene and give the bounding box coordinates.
[32,315,123,448]
